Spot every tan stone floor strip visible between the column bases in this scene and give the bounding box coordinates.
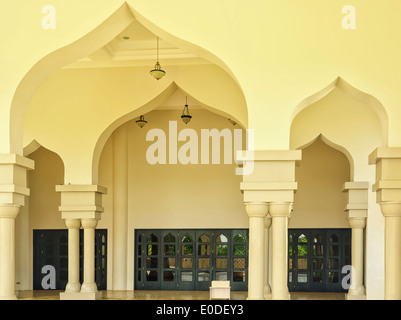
[17,290,345,300]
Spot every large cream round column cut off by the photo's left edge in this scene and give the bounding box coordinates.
[0,205,19,300]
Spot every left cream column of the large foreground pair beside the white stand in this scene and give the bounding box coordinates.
[245,202,268,300]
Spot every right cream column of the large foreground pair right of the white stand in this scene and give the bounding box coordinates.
[269,203,291,300]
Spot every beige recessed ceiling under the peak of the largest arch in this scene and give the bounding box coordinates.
[65,20,210,68]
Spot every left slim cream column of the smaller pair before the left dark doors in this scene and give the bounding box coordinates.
[65,219,81,293]
